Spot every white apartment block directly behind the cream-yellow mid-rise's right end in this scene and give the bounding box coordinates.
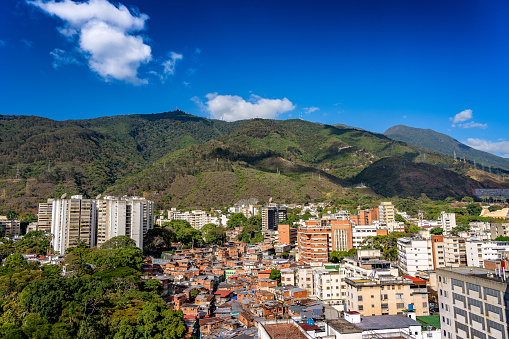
[398,238,433,277]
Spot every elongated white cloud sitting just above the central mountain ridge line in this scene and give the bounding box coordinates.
[196,93,295,121]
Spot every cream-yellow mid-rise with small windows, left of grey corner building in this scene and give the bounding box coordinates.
[345,275,429,316]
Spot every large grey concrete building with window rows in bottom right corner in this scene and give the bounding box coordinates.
[437,267,509,339]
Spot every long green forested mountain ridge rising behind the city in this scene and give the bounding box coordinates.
[0,111,508,211]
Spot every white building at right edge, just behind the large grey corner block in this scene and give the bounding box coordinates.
[465,240,509,267]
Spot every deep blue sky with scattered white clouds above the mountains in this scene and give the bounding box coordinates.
[0,0,509,157]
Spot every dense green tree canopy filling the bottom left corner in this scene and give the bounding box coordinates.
[0,233,187,339]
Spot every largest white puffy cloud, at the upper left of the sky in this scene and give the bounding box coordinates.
[26,0,181,85]
